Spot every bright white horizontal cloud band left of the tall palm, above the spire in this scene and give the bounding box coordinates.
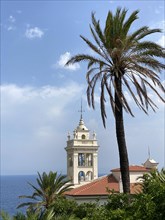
[1,82,82,109]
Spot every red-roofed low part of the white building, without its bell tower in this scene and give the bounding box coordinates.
[65,165,158,205]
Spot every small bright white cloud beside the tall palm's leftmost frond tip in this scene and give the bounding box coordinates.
[55,52,80,71]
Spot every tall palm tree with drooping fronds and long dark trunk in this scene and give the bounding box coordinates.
[66,8,165,193]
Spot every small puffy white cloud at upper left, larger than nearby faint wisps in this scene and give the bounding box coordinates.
[25,27,44,39]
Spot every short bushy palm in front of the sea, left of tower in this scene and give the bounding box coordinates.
[17,172,73,213]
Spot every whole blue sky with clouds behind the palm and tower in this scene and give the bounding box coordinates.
[1,0,165,174]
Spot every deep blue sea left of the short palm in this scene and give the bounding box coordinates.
[0,175,37,216]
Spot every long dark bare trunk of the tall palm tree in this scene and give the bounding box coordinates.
[115,77,130,193]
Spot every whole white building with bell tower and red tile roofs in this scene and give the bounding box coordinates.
[65,112,158,204]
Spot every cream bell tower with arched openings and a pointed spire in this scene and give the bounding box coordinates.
[65,105,99,187]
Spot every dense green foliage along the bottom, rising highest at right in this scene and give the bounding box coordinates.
[1,170,165,220]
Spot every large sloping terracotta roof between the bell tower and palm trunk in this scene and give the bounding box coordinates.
[65,174,119,196]
